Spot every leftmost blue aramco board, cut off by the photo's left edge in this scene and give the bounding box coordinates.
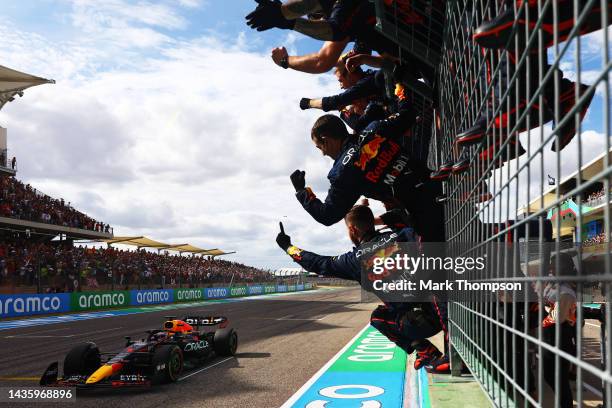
[0,293,70,318]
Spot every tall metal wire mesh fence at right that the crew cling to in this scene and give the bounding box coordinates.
[375,0,612,407]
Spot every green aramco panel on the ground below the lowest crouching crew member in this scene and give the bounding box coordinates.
[329,327,406,372]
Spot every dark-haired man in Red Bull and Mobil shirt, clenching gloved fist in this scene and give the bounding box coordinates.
[291,102,445,242]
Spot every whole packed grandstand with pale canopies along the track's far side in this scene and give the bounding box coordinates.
[0,66,278,293]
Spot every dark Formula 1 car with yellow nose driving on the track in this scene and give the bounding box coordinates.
[40,316,238,388]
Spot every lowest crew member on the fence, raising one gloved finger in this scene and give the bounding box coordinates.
[276,205,448,371]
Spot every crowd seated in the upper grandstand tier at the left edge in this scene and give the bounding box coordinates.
[0,176,112,233]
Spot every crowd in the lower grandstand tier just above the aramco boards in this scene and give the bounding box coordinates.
[0,239,271,292]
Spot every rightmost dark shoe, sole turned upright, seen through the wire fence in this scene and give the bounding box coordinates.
[551,78,594,152]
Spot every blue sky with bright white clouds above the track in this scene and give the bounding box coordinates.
[0,0,604,268]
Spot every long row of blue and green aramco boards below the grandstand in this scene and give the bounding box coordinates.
[0,283,314,319]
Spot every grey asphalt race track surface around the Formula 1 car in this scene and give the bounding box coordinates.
[0,288,374,408]
